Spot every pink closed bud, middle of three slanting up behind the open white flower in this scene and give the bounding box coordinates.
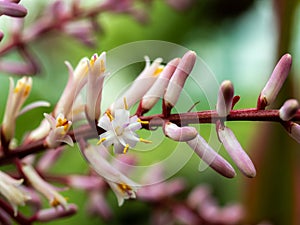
[139,58,180,114]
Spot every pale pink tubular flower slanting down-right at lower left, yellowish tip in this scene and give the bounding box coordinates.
[21,164,68,210]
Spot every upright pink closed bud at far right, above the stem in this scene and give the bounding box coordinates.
[257,54,292,109]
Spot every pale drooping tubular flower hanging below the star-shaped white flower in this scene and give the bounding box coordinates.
[84,145,137,206]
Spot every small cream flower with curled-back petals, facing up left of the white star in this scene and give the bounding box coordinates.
[44,113,73,148]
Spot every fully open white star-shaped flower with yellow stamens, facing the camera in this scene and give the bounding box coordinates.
[98,109,149,153]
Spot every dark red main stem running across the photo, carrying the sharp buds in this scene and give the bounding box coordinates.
[0,108,300,165]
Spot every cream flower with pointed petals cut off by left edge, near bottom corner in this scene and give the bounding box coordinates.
[0,171,31,216]
